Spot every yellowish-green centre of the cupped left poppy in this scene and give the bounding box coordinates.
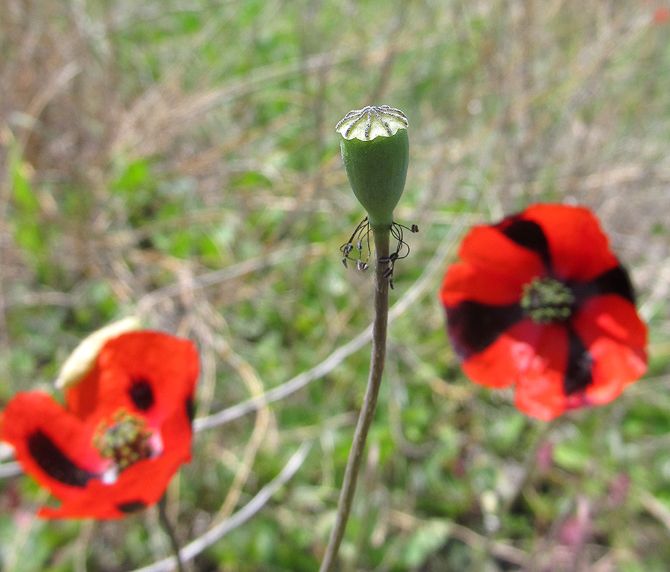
[93,409,153,472]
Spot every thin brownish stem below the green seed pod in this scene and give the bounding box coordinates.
[320,227,390,572]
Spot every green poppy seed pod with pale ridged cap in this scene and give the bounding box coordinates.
[335,105,409,229]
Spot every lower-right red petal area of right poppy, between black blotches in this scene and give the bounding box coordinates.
[573,295,647,404]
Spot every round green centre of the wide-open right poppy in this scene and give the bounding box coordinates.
[521,278,575,324]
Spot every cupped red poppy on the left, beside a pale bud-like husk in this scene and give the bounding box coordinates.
[0,331,198,519]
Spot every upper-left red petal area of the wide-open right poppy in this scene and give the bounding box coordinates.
[441,226,544,306]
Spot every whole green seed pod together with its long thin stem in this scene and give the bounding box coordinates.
[320,105,409,572]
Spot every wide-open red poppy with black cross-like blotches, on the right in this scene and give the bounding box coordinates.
[441,205,647,420]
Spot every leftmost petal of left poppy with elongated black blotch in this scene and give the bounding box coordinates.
[1,391,104,498]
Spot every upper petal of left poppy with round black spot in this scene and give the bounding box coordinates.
[66,331,199,427]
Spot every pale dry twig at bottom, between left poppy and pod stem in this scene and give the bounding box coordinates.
[134,443,312,572]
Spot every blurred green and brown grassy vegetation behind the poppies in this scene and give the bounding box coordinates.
[0,0,670,572]
